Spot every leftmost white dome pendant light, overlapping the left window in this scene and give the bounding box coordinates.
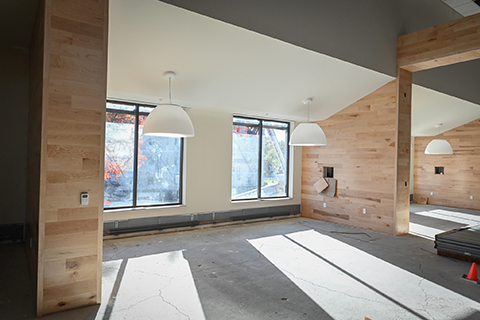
[143,71,195,138]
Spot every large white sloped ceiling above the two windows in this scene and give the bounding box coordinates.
[107,0,393,121]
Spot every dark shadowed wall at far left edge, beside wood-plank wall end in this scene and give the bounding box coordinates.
[0,0,38,224]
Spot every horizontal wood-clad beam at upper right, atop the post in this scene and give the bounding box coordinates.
[397,13,480,72]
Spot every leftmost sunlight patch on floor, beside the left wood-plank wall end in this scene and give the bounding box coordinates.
[96,251,205,320]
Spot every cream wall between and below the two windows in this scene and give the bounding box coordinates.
[104,109,302,221]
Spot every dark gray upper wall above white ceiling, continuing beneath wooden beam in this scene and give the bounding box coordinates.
[163,0,480,104]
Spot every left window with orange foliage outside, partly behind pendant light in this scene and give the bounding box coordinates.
[104,102,183,208]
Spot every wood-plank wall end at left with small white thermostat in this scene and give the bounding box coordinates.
[27,0,108,316]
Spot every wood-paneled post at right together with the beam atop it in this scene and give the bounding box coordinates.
[395,13,480,235]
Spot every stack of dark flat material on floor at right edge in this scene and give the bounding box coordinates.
[435,225,480,263]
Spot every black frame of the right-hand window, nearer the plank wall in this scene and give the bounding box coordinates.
[230,115,291,202]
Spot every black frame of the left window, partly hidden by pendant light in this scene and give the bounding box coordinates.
[103,99,185,211]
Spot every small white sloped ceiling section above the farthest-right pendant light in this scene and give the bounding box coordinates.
[412,85,480,137]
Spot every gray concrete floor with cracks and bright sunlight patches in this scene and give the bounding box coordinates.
[0,205,480,320]
